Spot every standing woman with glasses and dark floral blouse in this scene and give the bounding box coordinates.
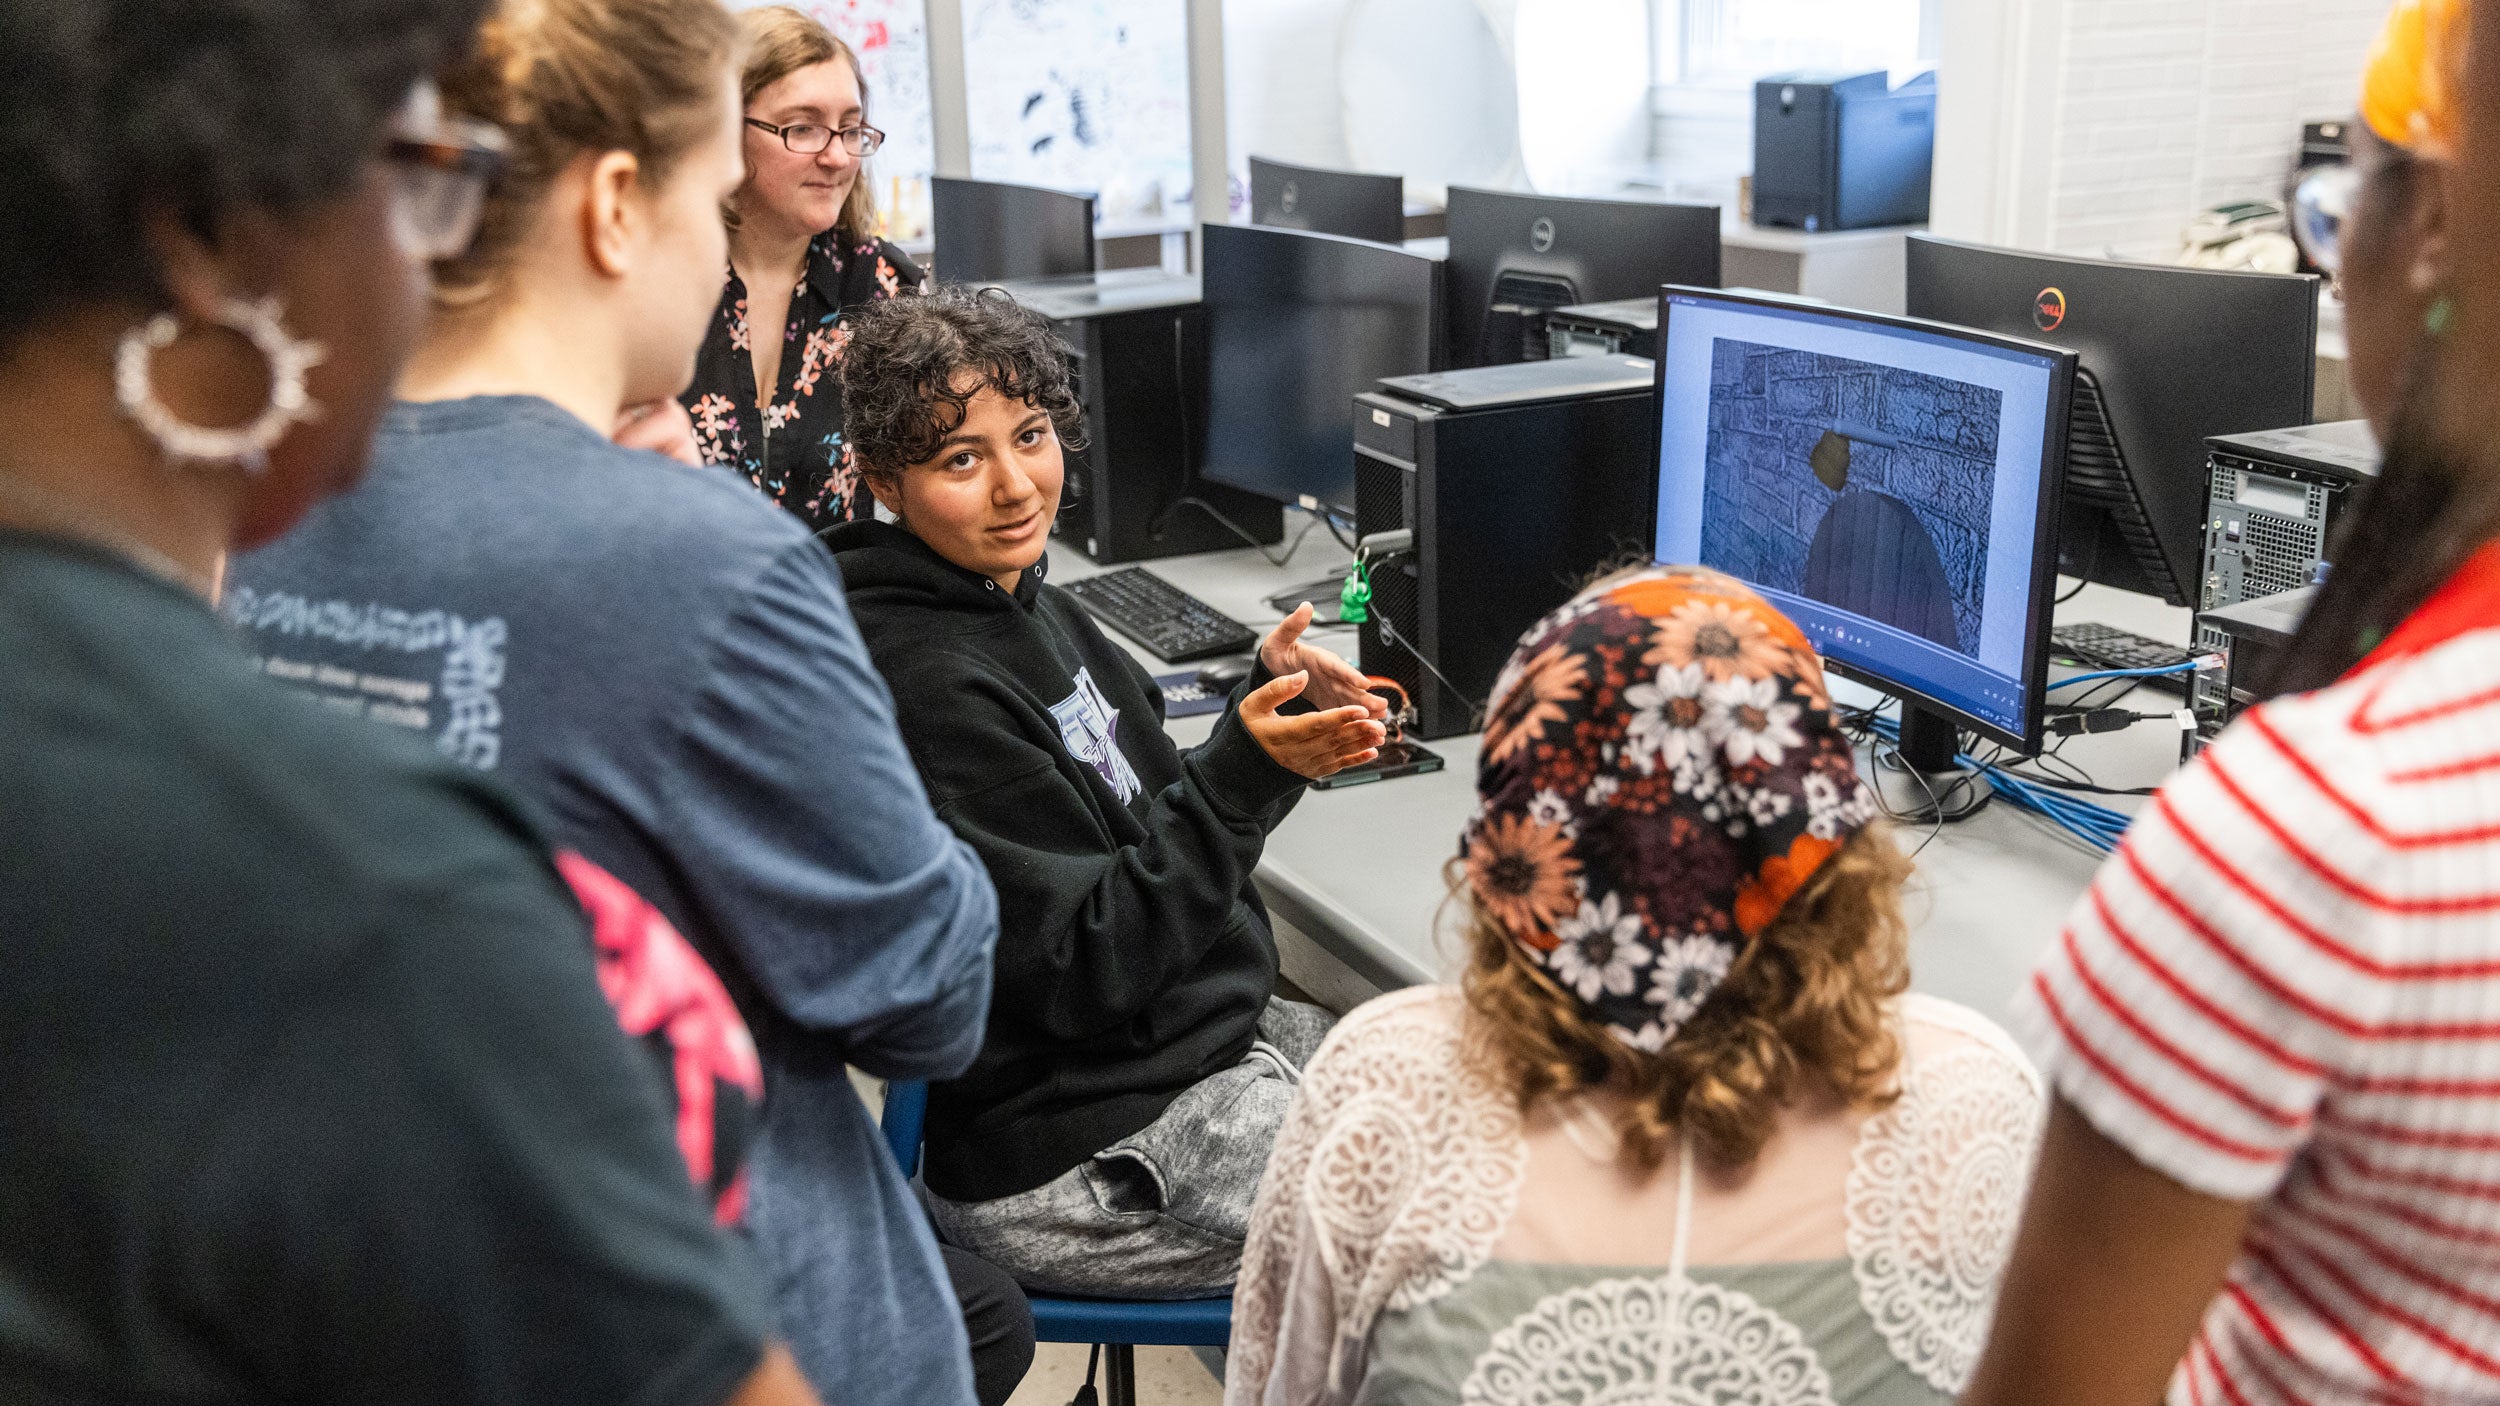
[678,5,923,530]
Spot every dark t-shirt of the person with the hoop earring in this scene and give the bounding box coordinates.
[0,533,768,1406]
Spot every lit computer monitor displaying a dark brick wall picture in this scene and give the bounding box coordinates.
[1655,288,2075,773]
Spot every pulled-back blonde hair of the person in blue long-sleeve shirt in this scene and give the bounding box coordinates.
[435,0,738,308]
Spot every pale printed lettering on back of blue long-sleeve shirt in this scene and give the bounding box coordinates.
[223,585,508,771]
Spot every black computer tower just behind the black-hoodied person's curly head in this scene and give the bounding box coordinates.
[998,268,1285,565]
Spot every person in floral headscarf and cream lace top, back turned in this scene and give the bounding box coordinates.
[1225,568,2040,1406]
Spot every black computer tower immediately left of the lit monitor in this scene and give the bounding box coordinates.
[1355,355,1658,738]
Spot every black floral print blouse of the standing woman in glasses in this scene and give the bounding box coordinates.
[678,230,925,530]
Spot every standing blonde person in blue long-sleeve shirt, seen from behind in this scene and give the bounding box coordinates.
[228,0,1028,1406]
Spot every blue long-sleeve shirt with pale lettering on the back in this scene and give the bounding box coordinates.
[225,395,998,1406]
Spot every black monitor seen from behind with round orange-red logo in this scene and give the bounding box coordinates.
[1908,235,2318,605]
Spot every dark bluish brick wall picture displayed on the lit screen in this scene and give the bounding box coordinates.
[1703,338,2003,655]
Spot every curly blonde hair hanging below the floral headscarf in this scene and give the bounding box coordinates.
[1450,823,1910,1171]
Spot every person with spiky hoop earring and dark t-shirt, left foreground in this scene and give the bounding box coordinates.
[0,0,815,1406]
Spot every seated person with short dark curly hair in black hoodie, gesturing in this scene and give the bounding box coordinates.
[828,288,1388,1298]
